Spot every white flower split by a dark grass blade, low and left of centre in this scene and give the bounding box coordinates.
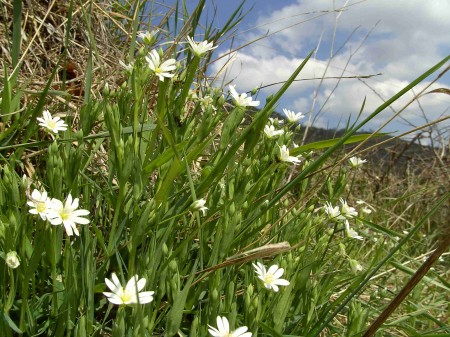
[103,273,155,305]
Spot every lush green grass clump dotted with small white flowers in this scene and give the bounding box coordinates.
[0,1,450,337]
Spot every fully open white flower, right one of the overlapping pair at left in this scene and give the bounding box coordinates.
[47,194,89,236]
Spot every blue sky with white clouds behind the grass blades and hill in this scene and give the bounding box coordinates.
[156,0,450,143]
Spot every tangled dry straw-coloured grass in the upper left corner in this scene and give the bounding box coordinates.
[0,0,120,110]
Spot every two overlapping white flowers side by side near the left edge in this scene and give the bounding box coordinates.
[27,190,89,236]
